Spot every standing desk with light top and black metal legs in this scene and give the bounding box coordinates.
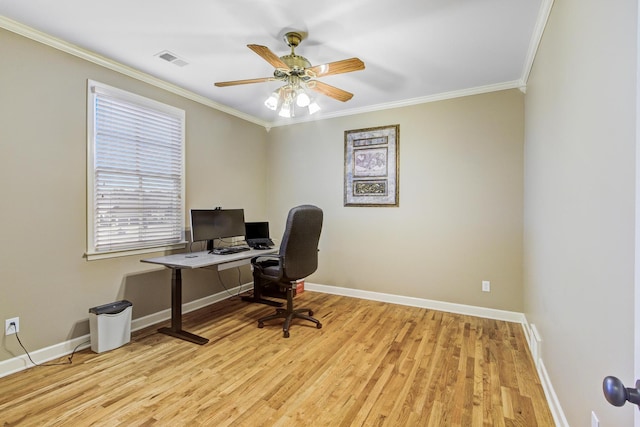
[141,249,278,345]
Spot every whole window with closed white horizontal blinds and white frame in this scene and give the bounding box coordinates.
[87,80,185,259]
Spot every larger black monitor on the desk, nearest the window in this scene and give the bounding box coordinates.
[191,209,245,242]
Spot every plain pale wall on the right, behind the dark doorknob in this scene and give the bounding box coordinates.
[524,0,638,426]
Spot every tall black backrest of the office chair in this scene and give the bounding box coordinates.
[280,205,322,281]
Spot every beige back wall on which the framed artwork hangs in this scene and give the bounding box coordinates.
[268,90,524,312]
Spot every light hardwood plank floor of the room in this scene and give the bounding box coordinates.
[0,291,554,427]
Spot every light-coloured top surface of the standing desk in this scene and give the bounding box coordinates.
[140,248,278,270]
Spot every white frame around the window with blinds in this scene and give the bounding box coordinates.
[85,79,187,261]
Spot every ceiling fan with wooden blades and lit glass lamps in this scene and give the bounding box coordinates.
[215,31,364,115]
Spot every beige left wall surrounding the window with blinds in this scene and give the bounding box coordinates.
[0,29,266,360]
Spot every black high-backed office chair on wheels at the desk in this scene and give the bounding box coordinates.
[251,205,322,338]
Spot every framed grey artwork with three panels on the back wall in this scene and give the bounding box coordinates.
[344,125,400,207]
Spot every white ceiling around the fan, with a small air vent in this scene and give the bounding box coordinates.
[0,0,552,126]
